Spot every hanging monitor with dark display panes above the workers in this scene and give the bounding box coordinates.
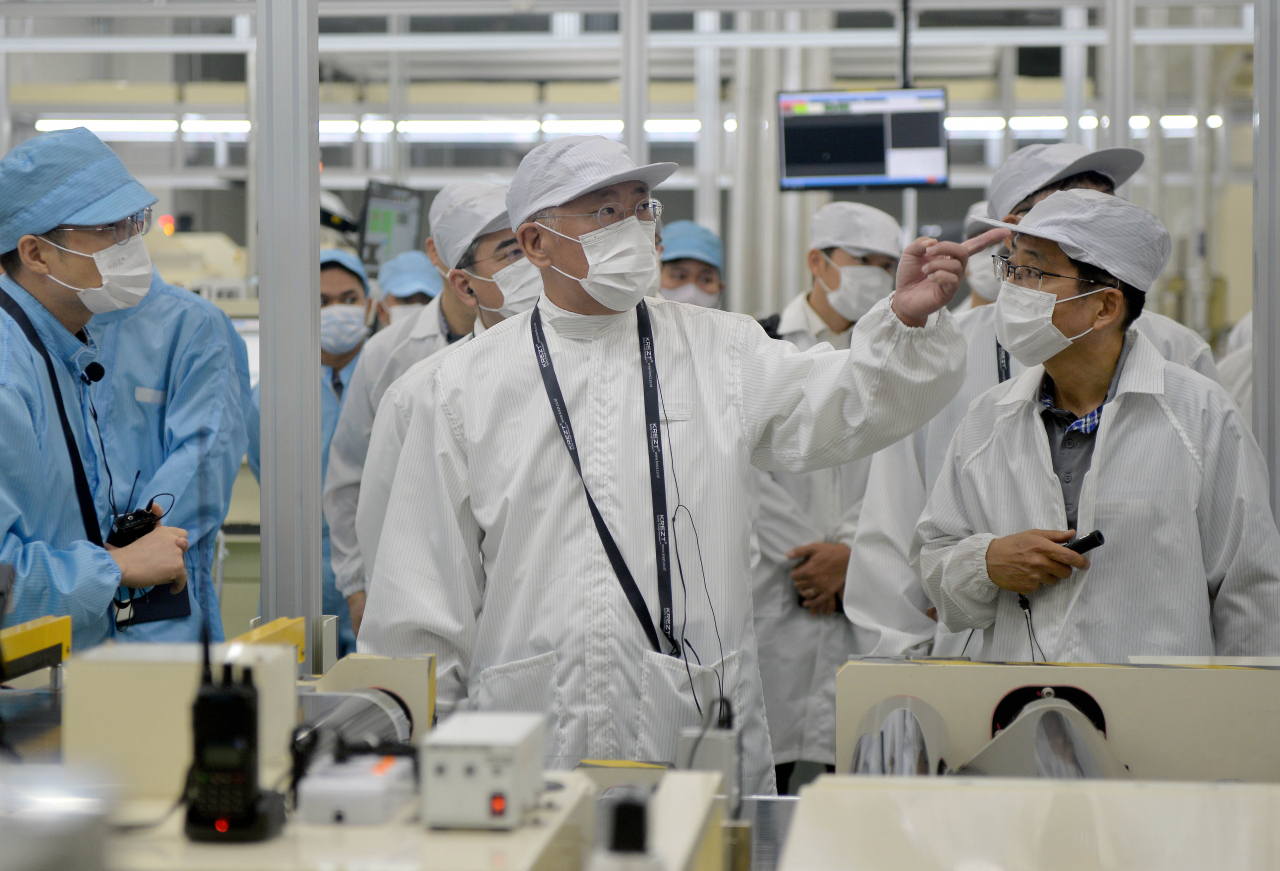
[778,88,947,191]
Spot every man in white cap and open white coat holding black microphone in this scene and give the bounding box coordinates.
[911,191,1280,663]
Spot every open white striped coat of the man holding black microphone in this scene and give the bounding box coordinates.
[911,330,1280,662]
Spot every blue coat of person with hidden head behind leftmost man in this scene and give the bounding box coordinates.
[88,273,250,642]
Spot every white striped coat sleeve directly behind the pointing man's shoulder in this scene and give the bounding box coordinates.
[356,318,485,589]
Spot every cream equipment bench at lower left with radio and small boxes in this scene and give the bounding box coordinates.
[0,617,750,871]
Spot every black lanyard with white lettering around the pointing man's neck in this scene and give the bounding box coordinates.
[529,301,680,656]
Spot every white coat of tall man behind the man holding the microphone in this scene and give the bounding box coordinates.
[845,305,1217,656]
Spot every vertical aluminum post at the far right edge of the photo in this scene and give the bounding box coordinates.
[1253,3,1280,511]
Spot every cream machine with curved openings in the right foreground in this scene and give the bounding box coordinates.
[762,658,1280,871]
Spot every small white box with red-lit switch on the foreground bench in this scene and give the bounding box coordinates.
[420,711,547,829]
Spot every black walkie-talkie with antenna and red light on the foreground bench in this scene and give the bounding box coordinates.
[184,630,284,843]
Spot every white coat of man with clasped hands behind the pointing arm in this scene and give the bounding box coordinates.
[753,295,870,765]
